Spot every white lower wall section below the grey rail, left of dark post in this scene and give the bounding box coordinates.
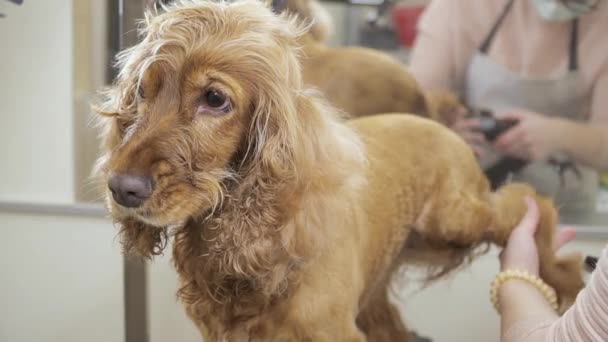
[0,213,124,342]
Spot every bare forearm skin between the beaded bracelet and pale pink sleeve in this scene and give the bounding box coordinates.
[498,279,558,342]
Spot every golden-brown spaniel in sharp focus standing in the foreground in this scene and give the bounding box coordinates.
[99,1,582,342]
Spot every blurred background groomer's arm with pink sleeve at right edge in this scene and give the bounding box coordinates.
[556,69,608,171]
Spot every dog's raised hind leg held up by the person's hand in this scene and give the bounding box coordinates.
[414,184,584,309]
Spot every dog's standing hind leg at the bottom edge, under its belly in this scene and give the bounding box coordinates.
[357,291,411,342]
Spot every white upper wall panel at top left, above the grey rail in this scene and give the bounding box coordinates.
[0,0,73,202]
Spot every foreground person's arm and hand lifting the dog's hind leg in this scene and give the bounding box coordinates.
[498,200,608,342]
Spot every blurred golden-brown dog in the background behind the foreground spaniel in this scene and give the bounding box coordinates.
[276,0,430,117]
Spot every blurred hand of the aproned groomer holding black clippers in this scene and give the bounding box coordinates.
[494,110,563,161]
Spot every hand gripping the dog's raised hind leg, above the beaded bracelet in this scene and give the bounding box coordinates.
[500,197,576,276]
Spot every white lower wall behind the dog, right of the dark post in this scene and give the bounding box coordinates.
[148,239,606,342]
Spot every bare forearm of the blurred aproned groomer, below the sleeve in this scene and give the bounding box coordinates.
[555,119,608,171]
